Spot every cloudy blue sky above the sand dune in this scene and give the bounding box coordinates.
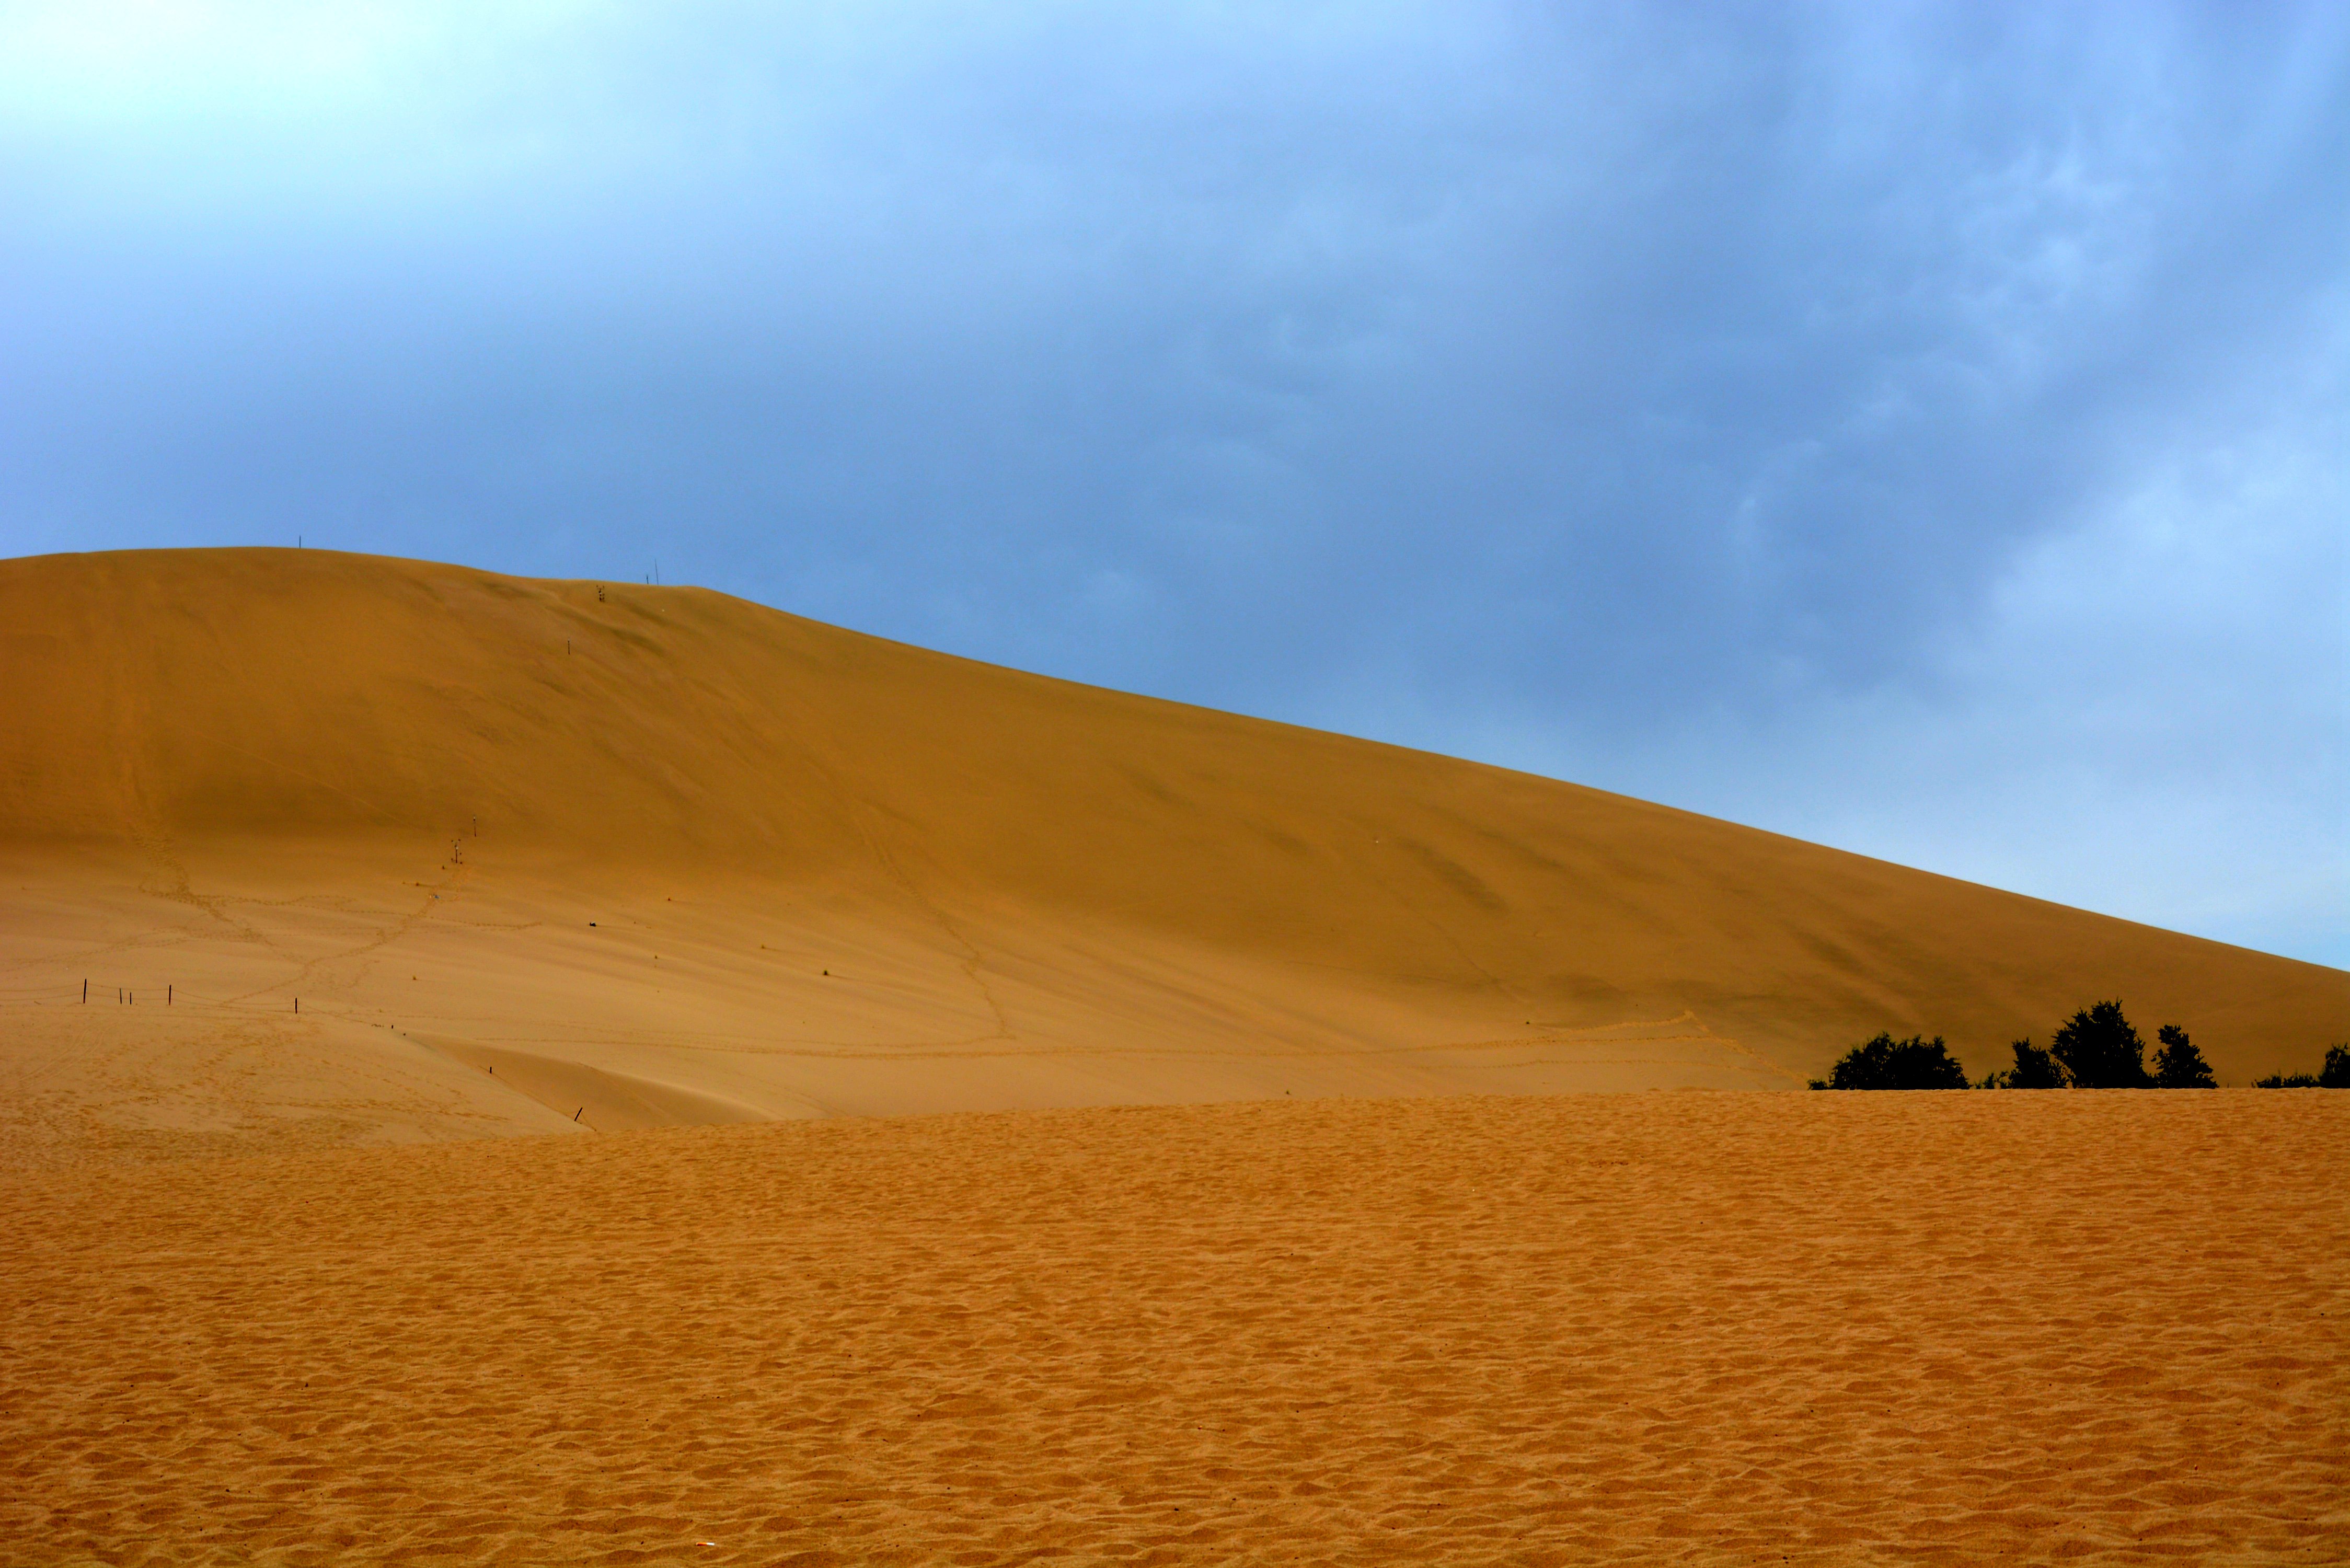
[0,0,2350,966]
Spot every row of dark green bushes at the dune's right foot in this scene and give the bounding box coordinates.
[1812,1001,2350,1088]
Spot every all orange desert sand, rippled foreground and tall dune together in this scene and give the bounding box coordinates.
[0,550,2350,1563]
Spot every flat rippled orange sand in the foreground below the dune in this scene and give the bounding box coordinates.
[0,1091,2350,1563]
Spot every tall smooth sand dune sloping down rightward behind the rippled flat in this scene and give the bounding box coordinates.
[0,550,2350,1147]
